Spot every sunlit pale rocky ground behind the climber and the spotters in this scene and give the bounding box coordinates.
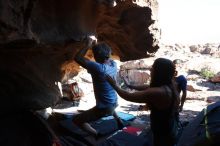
[53,44,220,127]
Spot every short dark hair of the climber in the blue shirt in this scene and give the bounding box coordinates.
[92,43,112,62]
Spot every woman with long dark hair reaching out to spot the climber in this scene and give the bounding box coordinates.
[107,58,179,146]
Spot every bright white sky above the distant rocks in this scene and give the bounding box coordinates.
[158,0,220,44]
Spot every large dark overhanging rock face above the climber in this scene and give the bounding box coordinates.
[0,0,159,114]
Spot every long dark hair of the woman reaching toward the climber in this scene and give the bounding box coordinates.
[150,58,175,87]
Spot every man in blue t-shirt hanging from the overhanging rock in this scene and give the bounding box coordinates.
[73,36,123,138]
